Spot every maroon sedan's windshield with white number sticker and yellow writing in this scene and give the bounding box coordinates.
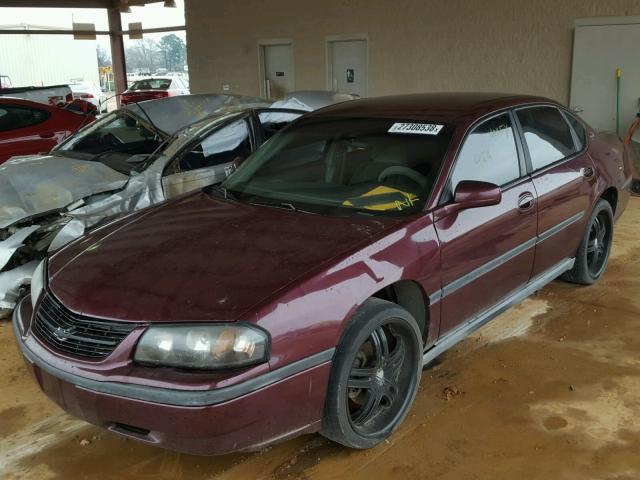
[222,117,453,216]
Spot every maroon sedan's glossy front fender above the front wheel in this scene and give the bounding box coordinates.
[246,215,441,369]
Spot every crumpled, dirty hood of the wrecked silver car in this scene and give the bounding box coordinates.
[0,155,129,228]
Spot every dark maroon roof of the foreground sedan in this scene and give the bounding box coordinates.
[309,92,557,124]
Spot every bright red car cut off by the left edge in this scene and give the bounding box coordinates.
[0,97,95,164]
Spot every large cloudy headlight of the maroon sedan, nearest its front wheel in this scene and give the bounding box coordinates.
[134,324,269,370]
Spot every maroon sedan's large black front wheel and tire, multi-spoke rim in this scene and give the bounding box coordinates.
[321,298,422,449]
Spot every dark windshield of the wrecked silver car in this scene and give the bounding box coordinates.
[54,110,165,175]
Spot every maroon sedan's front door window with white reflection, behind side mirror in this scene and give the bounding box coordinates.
[451,113,520,192]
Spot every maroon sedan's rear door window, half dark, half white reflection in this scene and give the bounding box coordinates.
[516,107,578,170]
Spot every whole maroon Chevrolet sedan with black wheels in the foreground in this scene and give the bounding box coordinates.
[14,94,630,454]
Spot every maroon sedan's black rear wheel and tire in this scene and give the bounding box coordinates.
[562,199,613,285]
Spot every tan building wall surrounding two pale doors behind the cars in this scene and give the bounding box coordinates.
[185,0,640,103]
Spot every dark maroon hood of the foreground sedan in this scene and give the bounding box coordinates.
[49,192,398,322]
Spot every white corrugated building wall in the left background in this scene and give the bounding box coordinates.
[0,34,99,87]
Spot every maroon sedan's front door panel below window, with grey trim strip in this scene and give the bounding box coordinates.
[436,177,537,335]
